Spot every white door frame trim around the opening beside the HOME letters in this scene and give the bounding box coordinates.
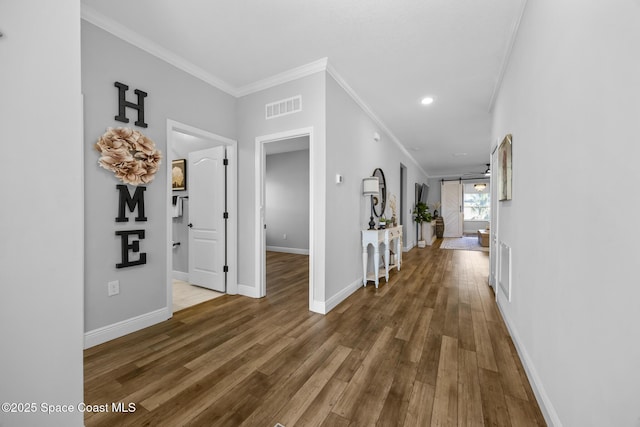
[165,119,238,315]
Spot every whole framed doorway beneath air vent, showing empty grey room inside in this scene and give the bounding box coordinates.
[256,128,313,309]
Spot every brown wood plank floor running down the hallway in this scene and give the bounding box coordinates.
[85,242,545,427]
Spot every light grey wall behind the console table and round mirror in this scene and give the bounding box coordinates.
[326,75,427,301]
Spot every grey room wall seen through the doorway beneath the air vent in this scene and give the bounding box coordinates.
[265,149,309,253]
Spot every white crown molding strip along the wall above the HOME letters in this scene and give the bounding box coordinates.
[80,4,237,96]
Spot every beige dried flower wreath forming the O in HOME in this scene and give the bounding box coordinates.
[95,128,162,185]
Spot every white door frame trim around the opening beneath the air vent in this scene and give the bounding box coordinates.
[255,127,318,311]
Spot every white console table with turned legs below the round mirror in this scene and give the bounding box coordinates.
[362,226,402,288]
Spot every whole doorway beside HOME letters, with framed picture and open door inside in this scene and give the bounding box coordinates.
[165,120,237,313]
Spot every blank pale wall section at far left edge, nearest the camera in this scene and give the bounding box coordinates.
[0,0,83,427]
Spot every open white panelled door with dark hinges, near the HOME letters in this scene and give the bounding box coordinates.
[187,146,225,292]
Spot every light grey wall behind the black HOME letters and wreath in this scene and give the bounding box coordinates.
[82,21,236,343]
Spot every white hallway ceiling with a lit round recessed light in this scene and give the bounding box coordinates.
[82,0,526,177]
